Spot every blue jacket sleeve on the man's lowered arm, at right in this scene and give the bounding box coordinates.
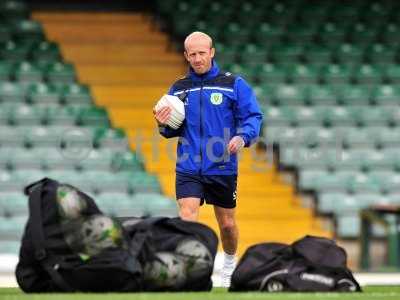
[235,77,263,147]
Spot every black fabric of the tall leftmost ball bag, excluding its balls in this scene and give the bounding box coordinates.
[15,178,142,293]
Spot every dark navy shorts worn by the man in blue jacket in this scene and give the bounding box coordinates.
[175,172,237,208]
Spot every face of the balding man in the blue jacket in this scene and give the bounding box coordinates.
[185,38,215,75]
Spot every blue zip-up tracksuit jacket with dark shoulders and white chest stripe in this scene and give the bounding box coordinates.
[160,61,262,175]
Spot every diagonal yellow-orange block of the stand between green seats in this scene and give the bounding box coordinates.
[34,9,330,253]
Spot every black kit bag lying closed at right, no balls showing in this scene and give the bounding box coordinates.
[229,236,361,292]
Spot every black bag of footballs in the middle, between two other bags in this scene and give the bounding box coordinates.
[122,217,218,291]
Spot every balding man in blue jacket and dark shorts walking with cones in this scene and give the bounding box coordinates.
[154,32,262,287]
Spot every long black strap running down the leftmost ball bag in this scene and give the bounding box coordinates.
[29,184,74,292]
